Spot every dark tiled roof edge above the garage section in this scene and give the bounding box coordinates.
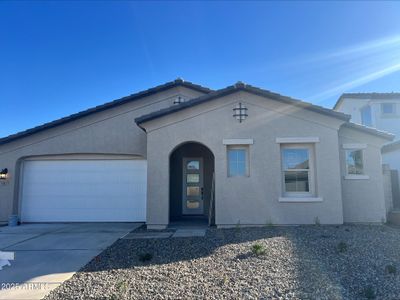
[0,78,212,145]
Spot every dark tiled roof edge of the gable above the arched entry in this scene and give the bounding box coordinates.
[135,82,350,125]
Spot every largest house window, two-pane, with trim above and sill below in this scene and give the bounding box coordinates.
[281,144,315,196]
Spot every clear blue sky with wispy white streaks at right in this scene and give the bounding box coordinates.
[0,1,400,136]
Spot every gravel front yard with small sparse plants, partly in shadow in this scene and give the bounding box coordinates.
[46,225,400,300]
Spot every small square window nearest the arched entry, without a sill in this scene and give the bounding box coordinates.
[228,146,249,177]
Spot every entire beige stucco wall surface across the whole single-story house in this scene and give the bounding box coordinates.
[0,87,385,228]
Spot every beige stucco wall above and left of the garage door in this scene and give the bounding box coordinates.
[0,87,205,221]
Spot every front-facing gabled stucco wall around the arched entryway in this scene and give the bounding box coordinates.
[143,92,343,228]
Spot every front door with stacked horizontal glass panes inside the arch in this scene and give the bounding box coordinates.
[182,157,204,215]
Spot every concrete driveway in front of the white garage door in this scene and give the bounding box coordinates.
[0,223,141,300]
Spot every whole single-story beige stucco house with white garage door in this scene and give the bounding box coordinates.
[0,79,393,229]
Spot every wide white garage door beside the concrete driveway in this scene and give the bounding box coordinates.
[20,160,147,222]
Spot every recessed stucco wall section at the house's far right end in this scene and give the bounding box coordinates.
[339,127,386,223]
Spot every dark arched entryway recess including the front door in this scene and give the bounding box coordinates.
[169,142,215,224]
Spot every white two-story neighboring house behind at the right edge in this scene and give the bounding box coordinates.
[333,93,400,214]
